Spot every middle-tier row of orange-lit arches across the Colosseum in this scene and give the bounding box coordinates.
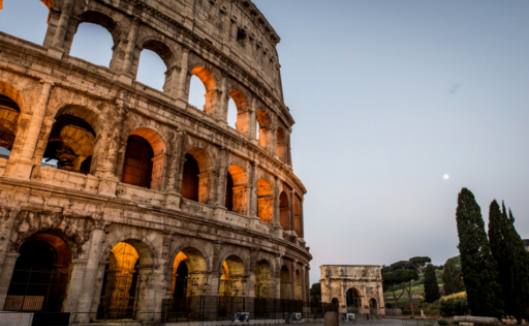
[0,86,302,236]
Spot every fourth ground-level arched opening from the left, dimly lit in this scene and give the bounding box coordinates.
[218,255,245,316]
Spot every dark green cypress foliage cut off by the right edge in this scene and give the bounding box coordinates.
[489,200,529,320]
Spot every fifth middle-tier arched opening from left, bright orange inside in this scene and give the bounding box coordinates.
[226,165,248,214]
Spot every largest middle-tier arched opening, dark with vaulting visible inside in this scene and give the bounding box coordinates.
[42,107,96,174]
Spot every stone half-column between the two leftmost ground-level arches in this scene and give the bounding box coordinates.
[74,229,105,323]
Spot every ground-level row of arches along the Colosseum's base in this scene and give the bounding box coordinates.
[4,230,305,319]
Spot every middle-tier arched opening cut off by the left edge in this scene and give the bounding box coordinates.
[0,94,20,157]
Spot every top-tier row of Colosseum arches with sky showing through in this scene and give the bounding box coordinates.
[0,2,290,163]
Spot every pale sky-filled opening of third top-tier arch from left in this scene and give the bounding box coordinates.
[136,49,167,91]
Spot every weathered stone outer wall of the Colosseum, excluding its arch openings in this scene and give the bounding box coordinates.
[0,0,311,323]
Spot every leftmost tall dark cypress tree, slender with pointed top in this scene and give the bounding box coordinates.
[456,188,503,317]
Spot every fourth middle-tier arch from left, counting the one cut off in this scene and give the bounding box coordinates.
[180,148,209,203]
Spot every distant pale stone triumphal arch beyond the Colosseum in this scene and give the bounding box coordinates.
[320,265,386,315]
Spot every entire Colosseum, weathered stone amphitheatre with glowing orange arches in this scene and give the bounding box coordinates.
[0,0,311,325]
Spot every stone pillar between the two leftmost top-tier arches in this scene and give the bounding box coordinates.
[44,0,74,52]
